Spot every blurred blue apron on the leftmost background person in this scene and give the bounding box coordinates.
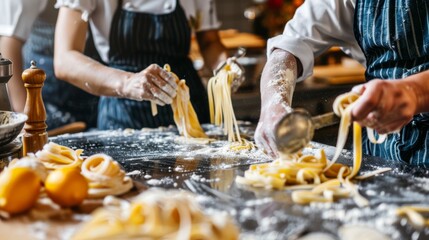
[23,19,98,130]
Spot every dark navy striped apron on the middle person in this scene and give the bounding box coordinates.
[98,1,209,129]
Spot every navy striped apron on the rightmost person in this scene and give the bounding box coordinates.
[354,0,429,167]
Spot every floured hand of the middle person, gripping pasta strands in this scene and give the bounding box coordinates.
[122,64,177,106]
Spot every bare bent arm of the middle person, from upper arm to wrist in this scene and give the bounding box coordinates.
[54,7,131,97]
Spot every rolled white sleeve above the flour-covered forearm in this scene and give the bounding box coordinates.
[267,0,358,81]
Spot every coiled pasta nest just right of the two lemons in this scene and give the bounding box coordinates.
[81,153,133,198]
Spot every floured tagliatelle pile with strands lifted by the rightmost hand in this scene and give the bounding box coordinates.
[236,93,390,206]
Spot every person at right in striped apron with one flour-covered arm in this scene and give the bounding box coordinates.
[255,0,429,167]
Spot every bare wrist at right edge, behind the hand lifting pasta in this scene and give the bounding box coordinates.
[403,70,429,114]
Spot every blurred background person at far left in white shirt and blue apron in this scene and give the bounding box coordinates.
[0,0,98,130]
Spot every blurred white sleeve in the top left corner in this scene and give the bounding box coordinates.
[0,0,47,41]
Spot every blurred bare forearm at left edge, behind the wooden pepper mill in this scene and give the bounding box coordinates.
[0,37,27,112]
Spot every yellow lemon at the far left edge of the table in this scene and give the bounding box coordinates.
[0,167,41,214]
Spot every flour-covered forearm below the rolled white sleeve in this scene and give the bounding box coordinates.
[261,49,301,112]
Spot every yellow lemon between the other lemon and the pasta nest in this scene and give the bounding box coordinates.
[45,167,88,207]
